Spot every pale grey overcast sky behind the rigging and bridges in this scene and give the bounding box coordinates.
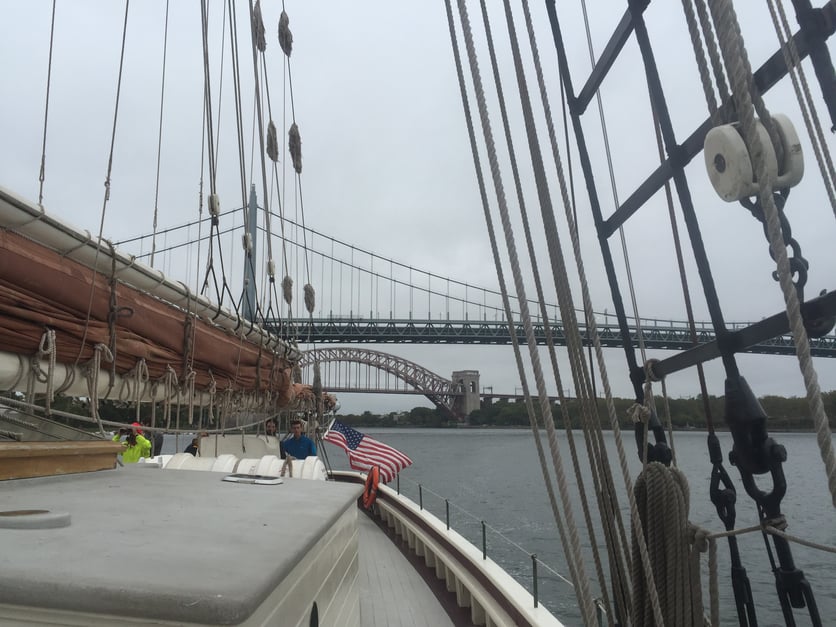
[0,0,836,418]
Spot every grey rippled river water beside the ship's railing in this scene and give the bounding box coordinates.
[326,429,836,627]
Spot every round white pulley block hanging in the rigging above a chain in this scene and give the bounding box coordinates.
[703,114,804,202]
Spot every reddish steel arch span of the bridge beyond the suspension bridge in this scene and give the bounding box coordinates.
[299,347,464,419]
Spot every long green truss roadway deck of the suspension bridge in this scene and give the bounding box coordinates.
[265,317,836,357]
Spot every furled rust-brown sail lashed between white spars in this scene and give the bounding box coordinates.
[0,189,299,409]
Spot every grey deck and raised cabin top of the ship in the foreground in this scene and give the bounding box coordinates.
[0,464,464,627]
